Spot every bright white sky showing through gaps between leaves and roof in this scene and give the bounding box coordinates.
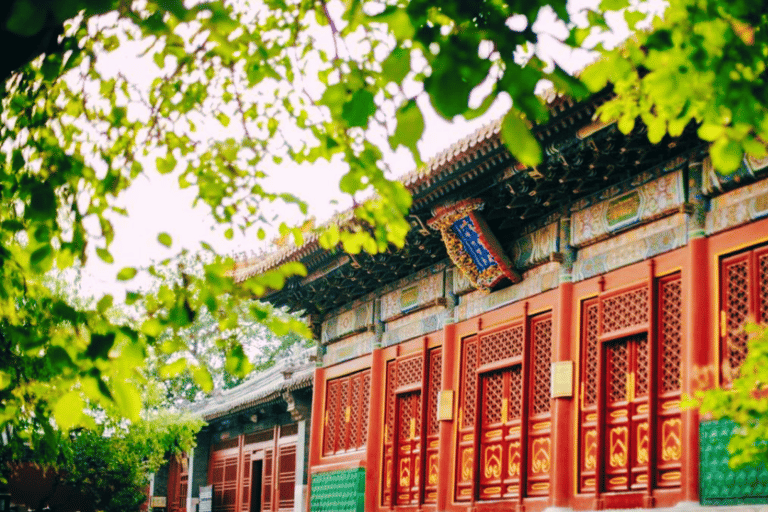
[76,1,648,300]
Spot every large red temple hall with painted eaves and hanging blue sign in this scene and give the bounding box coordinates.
[235,95,768,511]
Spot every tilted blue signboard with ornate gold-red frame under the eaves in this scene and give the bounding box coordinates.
[427,199,521,291]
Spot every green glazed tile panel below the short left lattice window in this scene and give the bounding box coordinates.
[310,468,365,512]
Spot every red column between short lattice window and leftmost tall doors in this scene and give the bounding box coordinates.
[365,344,387,510]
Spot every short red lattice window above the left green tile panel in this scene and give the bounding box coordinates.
[323,370,371,455]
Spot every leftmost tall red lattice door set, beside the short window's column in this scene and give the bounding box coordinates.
[381,347,442,506]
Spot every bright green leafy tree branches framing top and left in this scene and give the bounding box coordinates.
[0,0,768,460]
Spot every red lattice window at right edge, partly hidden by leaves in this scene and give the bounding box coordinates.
[720,246,768,383]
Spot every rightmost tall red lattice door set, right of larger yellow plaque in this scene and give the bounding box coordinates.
[578,273,682,493]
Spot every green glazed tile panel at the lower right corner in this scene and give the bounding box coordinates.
[699,420,768,505]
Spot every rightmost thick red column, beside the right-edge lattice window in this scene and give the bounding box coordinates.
[681,237,717,502]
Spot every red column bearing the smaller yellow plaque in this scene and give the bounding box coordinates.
[437,315,459,510]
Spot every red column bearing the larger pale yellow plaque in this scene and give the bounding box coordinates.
[549,279,575,507]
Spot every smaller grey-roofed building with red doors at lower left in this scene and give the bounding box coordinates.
[150,350,315,512]
